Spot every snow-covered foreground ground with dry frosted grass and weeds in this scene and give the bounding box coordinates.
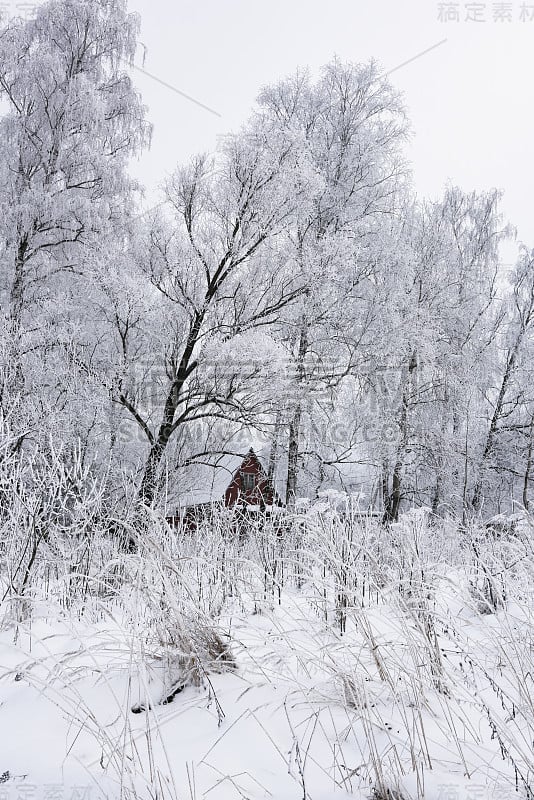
[0,520,534,800]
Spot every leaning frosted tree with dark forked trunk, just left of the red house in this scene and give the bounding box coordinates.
[86,130,308,505]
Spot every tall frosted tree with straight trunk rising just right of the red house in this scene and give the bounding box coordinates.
[255,61,406,503]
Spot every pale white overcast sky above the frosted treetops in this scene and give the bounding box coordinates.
[121,0,534,260]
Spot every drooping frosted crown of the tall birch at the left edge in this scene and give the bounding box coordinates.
[0,0,150,378]
